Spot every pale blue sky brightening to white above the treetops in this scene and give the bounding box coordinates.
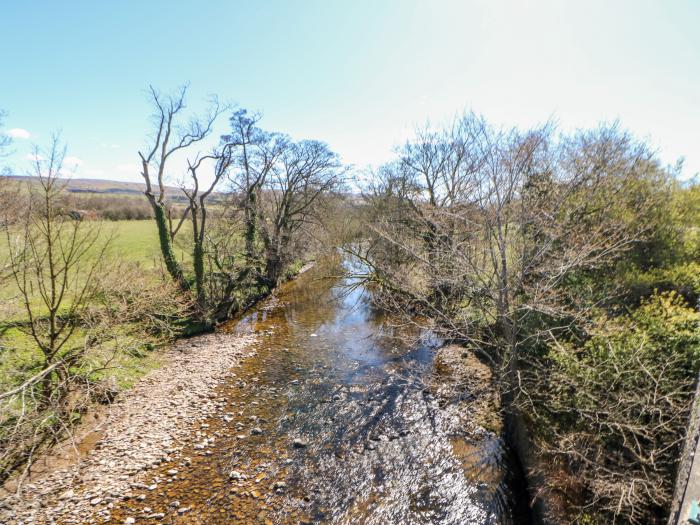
[0,0,700,182]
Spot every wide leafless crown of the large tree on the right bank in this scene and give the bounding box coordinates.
[356,115,654,363]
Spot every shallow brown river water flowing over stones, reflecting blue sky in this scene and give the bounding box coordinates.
[112,262,528,525]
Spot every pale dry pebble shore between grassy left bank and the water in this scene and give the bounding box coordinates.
[0,333,256,524]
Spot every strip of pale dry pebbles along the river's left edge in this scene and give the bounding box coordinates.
[0,334,257,524]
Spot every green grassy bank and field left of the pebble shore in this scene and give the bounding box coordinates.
[0,220,197,481]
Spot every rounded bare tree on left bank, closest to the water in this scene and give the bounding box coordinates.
[223,110,342,287]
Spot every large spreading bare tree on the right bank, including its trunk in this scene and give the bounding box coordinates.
[351,115,676,520]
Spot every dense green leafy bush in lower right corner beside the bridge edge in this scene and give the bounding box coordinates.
[519,292,700,523]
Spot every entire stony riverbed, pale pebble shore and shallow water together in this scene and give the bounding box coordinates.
[0,260,521,525]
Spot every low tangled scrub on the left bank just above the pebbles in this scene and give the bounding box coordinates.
[0,263,192,482]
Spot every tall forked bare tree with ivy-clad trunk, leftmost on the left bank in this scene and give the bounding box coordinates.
[139,86,226,288]
